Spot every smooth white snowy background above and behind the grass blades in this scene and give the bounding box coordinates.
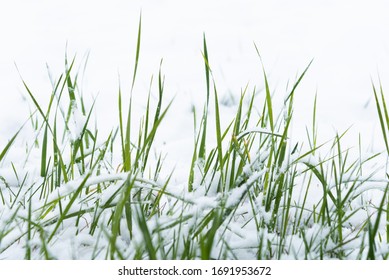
[0,0,389,258]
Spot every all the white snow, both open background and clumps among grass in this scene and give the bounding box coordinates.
[0,0,389,259]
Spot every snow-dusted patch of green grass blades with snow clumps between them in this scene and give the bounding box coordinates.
[0,19,389,259]
